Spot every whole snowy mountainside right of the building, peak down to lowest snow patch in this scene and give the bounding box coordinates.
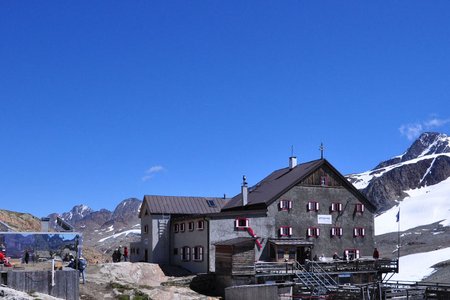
[348,132,450,283]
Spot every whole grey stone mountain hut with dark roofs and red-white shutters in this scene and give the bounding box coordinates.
[130,157,375,273]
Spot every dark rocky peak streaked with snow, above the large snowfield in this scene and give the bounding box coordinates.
[347,132,450,212]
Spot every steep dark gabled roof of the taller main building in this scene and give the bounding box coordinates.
[222,159,375,210]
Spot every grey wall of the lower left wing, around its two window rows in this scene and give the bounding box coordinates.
[169,218,209,273]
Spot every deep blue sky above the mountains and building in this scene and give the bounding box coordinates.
[0,0,450,216]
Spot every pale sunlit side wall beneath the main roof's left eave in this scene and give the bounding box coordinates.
[209,212,275,272]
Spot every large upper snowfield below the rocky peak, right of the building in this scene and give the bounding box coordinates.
[375,178,450,235]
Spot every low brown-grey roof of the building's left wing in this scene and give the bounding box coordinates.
[143,195,228,215]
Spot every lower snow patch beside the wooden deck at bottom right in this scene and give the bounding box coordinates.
[391,248,450,281]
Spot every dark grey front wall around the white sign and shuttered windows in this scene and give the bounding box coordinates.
[268,186,374,257]
